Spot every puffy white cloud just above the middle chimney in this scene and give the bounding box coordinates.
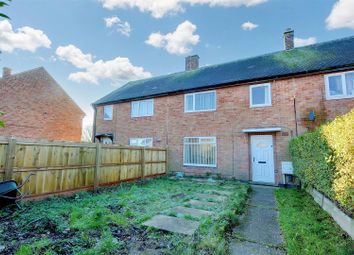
[145,20,199,55]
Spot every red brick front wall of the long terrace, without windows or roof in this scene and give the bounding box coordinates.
[96,70,354,183]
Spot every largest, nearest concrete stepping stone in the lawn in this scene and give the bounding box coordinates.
[143,215,199,235]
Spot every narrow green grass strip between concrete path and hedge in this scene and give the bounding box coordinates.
[276,189,354,255]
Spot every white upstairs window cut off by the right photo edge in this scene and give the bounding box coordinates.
[325,72,354,99]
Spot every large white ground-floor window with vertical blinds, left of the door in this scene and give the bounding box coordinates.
[183,137,217,167]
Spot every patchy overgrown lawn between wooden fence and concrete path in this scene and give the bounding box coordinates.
[0,178,248,255]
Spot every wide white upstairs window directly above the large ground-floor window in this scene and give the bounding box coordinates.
[184,91,216,112]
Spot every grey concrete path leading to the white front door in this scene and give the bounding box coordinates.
[230,185,285,255]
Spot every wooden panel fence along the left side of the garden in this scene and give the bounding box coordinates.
[0,138,167,197]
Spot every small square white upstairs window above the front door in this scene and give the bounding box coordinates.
[250,83,272,107]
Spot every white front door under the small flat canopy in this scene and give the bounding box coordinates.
[251,135,275,183]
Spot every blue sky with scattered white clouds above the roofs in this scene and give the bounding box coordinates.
[0,0,354,123]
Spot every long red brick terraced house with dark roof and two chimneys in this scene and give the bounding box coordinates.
[93,30,354,185]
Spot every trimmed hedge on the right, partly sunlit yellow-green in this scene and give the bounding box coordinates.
[289,109,354,212]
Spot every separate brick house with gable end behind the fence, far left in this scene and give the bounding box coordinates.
[0,67,85,141]
